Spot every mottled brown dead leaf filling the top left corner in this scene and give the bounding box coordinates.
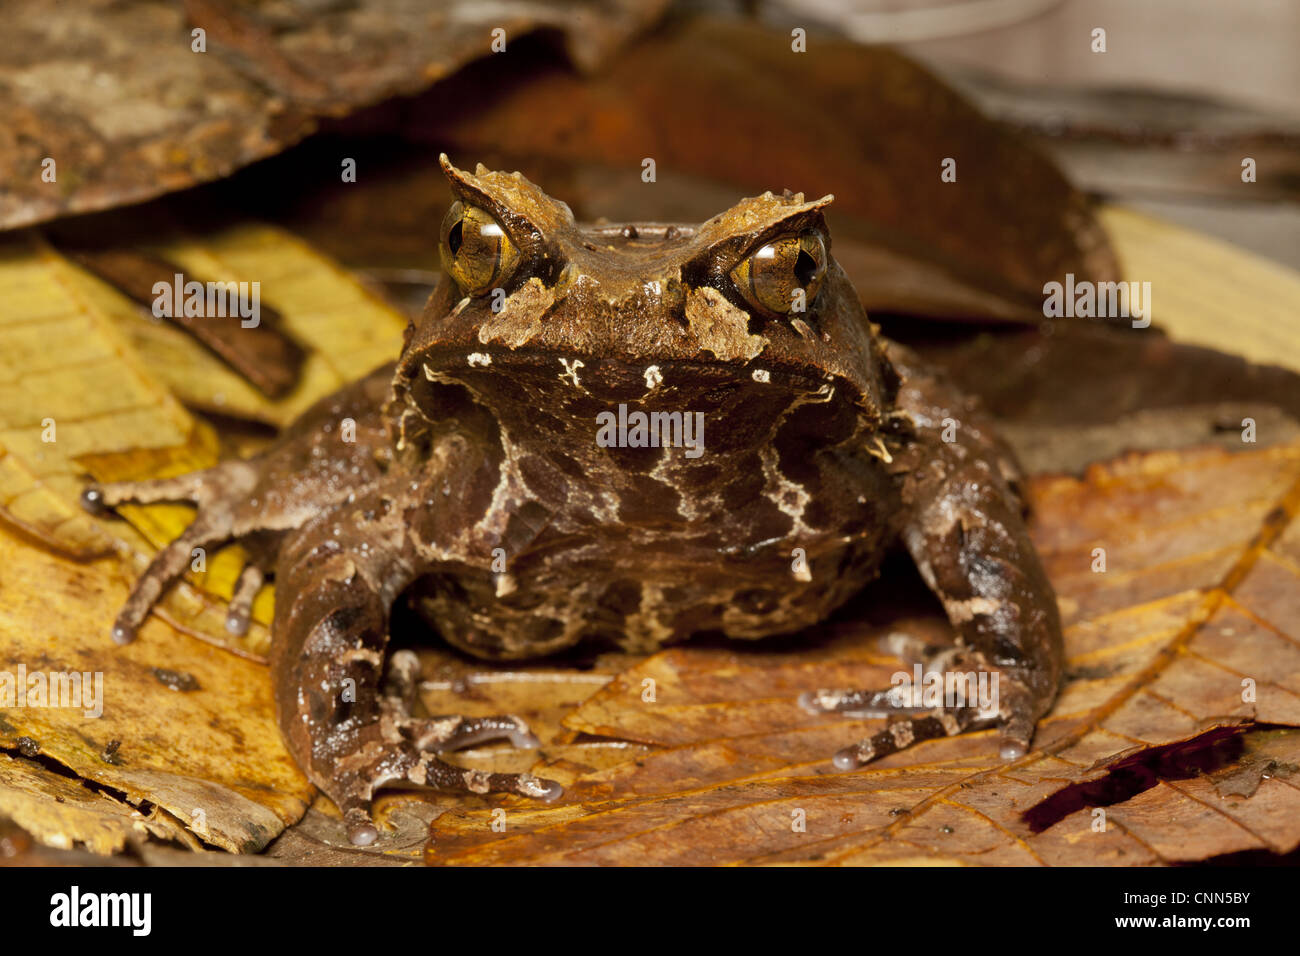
[0,0,664,229]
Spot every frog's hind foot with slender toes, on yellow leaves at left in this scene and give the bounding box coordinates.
[81,462,263,644]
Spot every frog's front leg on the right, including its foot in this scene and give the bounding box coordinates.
[805,346,1063,769]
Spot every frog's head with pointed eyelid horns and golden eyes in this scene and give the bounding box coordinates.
[384,156,888,468]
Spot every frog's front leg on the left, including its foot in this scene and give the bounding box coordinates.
[270,493,563,845]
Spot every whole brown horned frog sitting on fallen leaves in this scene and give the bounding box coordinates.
[82,155,1062,845]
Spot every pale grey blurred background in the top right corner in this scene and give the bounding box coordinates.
[748,0,1300,268]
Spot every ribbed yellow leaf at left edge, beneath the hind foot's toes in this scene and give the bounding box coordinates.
[0,235,268,654]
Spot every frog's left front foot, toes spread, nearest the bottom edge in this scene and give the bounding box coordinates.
[322,717,564,847]
